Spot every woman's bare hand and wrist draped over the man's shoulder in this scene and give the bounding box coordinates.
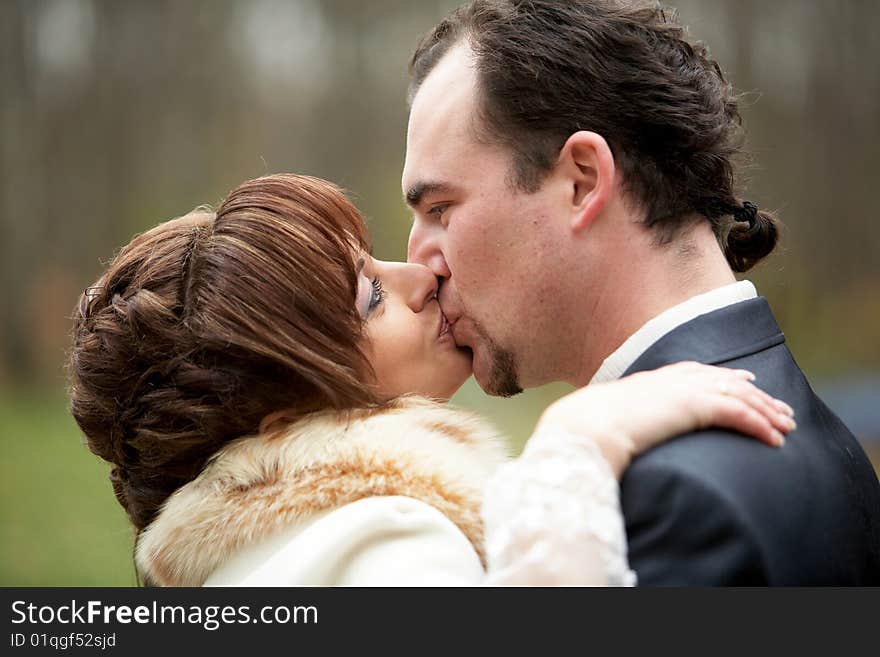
[536,362,795,478]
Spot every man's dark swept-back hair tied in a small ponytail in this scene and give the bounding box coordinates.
[409,0,778,272]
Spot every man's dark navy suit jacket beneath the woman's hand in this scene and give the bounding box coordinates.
[621,298,880,586]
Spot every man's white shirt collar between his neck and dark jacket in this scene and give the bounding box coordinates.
[590,281,758,384]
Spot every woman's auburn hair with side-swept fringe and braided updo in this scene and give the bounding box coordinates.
[68,174,379,531]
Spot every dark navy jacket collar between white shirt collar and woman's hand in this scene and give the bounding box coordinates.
[624,297,785,376]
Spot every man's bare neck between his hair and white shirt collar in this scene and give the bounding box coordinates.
[569,223,736,386]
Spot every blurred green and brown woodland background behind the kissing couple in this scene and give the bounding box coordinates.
[0,0,880,586]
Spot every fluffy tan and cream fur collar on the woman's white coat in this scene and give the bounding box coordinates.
[135,398,505,586]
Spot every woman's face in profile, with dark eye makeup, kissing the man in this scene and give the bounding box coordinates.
[357,255,471,400]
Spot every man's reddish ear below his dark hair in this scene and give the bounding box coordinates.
[559,130,615,233]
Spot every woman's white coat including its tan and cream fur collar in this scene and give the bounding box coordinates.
[136,398,506,586]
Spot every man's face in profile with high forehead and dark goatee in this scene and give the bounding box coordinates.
[402,45,564,395]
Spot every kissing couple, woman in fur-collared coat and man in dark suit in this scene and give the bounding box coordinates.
[69,0,880,586]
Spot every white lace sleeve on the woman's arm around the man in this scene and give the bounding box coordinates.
[483,428,636,586]
